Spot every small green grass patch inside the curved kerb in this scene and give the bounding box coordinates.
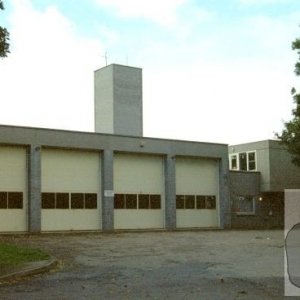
[0,243,49,266]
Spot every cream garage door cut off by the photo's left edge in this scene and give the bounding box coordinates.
[0,147,27,232]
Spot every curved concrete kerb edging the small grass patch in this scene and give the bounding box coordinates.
[0,257,58,283]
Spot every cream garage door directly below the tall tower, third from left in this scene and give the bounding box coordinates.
[114,154,164,229]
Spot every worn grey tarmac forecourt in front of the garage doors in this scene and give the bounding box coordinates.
[0,230,300,300]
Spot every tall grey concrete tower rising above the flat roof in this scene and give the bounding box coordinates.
[94,64,143,136]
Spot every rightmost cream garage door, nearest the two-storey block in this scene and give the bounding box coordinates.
[176,158,219,228]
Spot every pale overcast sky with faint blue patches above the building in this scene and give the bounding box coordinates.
[0,0,300,144]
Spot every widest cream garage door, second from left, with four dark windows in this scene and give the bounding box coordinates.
[42,149,101,231]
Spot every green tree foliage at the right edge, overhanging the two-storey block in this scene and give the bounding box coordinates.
[277,38,300,167]
